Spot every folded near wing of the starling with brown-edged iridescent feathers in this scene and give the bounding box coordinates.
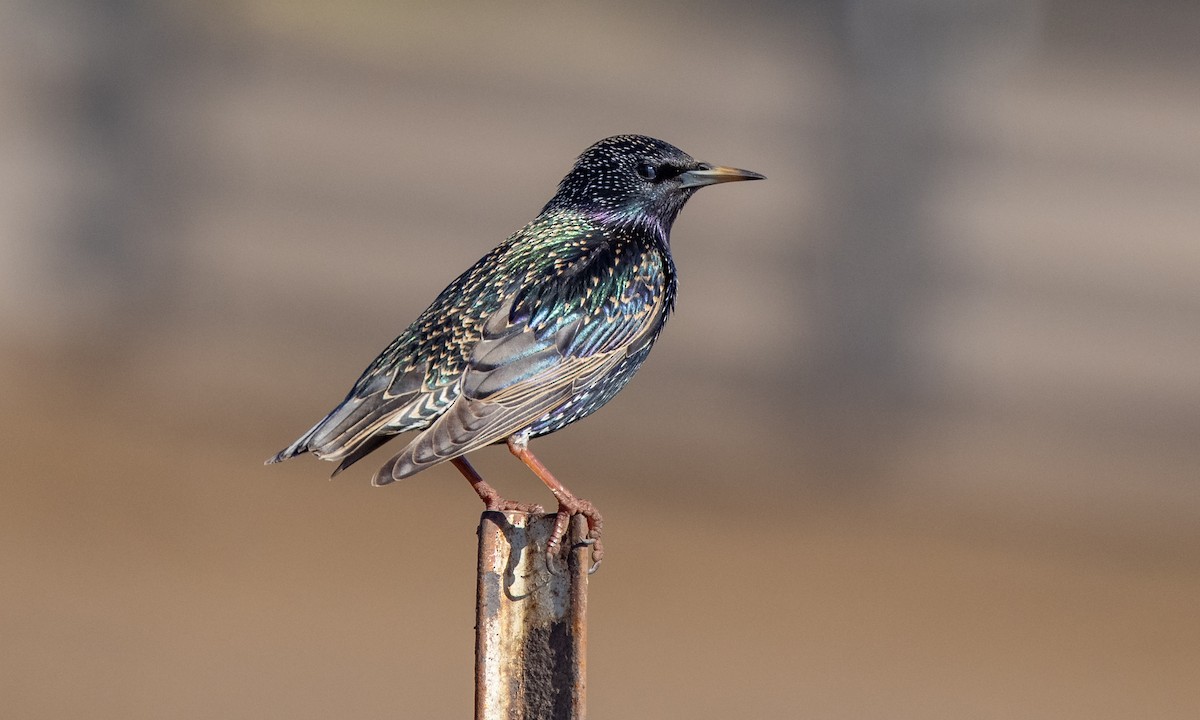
[376,237,670,484]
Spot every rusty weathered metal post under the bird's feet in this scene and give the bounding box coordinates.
[475,511,590,720]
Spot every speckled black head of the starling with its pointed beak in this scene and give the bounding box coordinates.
[546,134,763,235]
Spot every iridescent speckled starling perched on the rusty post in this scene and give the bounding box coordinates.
[266,134,764,570]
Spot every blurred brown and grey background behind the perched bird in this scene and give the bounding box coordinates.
[0,0,1200,720]
